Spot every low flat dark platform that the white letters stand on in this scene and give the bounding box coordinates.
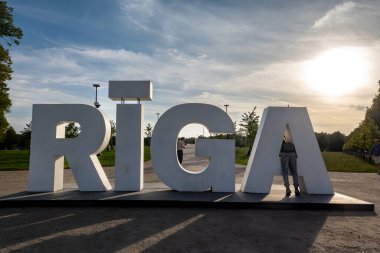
[0,183,374,211]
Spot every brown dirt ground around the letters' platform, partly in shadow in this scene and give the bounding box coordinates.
[0,145,380,253]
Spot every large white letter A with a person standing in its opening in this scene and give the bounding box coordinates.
[241,107,334,194]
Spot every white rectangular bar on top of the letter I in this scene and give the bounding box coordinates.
[108,81,153,101]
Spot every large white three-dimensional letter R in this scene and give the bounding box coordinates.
[29,104,111,192]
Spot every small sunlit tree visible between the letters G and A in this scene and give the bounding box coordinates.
[239,106,259,155]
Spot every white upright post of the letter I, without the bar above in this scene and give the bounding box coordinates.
[115,104,144,191]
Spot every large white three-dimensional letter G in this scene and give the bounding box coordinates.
[151,104,235,192]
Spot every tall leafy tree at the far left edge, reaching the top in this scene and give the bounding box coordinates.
[0,1,23,139]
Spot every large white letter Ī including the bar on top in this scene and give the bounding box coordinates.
[108,81,152,191]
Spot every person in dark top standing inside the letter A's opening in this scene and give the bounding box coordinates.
[280,136,300,197]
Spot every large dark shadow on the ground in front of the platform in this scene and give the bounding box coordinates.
[0,208,374,252]
